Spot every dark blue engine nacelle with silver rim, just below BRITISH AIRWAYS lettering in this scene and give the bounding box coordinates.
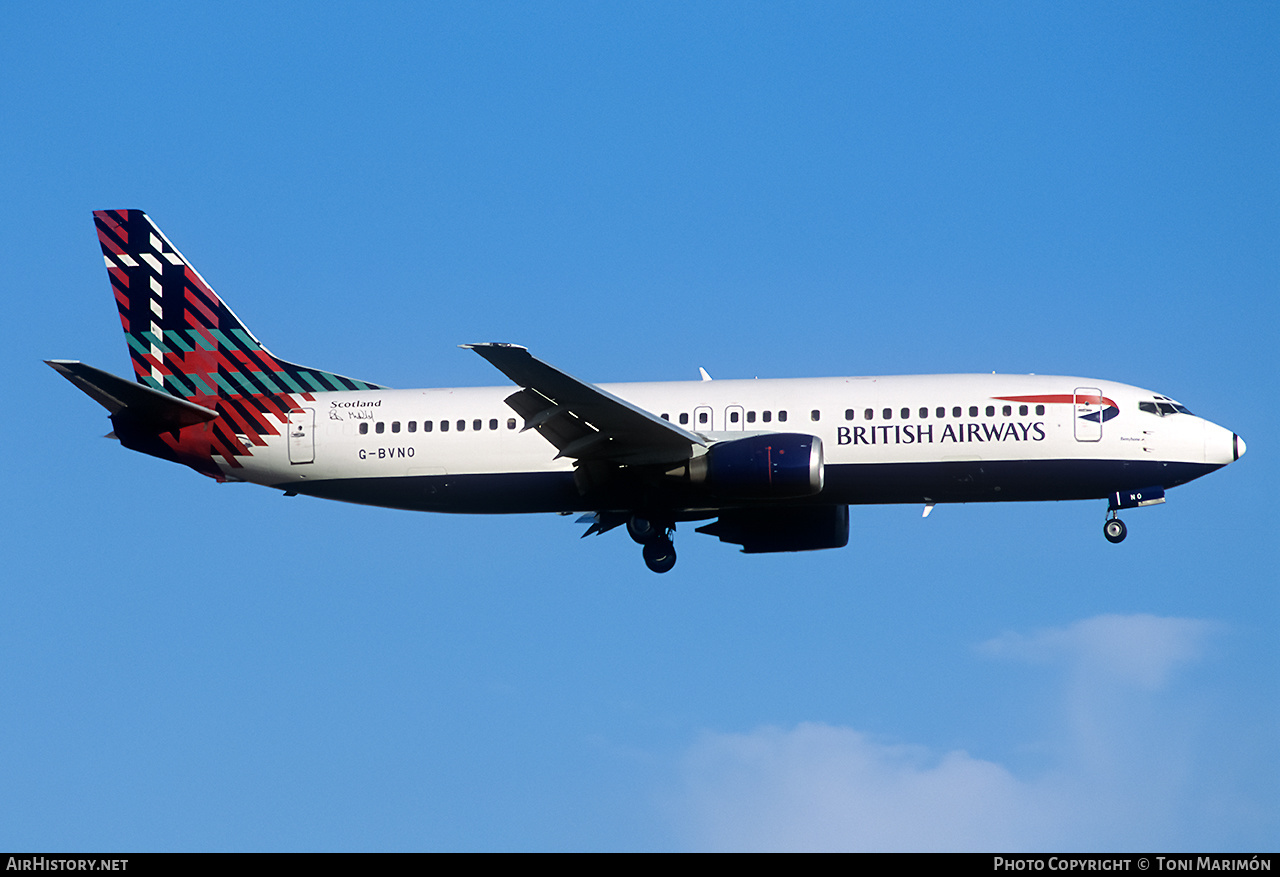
[689,433,824,499]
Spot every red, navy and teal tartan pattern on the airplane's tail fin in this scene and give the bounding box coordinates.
[93,210,383,466]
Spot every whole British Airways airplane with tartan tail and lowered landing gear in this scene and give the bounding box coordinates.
[46,210,1244,572]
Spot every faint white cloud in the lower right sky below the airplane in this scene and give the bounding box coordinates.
[680,616,1216,851]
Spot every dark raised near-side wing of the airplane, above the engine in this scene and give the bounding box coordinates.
[461,343,707,465]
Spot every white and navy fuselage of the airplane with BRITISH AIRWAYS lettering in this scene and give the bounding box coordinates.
[232,375,1243,512]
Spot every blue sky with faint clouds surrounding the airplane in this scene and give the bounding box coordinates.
[0,3,1280,850]
